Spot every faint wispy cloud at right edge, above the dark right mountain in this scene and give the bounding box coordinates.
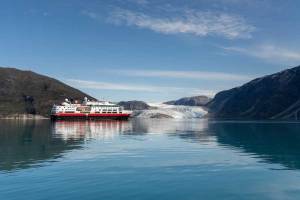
[222,44,300,64]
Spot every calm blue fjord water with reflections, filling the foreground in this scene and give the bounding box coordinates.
[0,120,300,200]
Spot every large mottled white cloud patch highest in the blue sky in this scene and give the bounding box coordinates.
[108,9,255,39]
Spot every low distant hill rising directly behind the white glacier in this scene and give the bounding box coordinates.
[164,95,211,106]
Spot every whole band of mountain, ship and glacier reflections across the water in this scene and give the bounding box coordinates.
[0,119,300,171]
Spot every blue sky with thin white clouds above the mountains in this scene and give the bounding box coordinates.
[0,0,300,102]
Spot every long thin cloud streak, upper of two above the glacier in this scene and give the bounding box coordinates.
[105,69,252,81]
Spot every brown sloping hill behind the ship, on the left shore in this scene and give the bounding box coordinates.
[0,67,94,117]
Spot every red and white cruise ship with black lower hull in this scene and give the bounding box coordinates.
[51,97,131,120]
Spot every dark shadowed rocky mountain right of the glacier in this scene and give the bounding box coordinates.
[208,66,300,120]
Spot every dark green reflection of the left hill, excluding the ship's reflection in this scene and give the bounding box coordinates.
[0,121,81,171]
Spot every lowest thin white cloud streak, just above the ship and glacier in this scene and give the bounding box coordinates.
[66,79,216,96]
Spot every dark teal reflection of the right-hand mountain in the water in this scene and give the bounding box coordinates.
[209,122,300,169]
